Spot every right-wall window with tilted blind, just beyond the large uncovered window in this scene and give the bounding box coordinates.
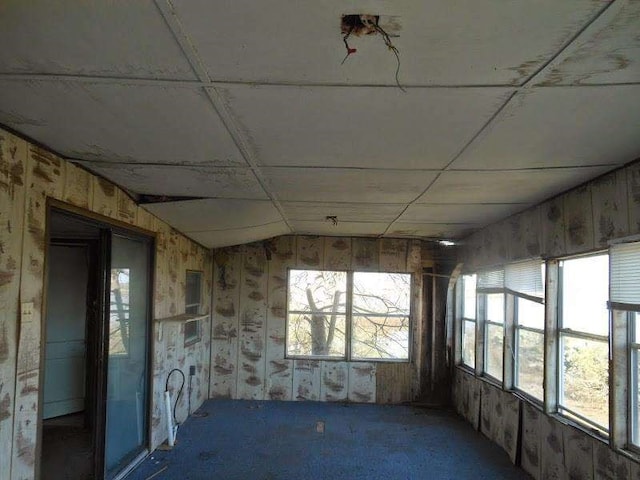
[505,260,545,401]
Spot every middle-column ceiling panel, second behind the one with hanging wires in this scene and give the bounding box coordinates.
[262,167,436,203]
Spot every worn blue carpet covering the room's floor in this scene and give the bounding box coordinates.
[127,400,530,480]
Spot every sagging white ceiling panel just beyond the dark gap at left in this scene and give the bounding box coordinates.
[144,198,282,232]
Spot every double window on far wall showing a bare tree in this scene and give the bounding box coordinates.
[286,270,411,360]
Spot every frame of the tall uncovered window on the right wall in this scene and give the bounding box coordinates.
[556,253,613,438]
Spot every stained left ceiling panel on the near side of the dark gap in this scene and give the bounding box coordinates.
[78,162,267,200]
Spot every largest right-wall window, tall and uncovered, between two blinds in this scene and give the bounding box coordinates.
[558,254,609,431]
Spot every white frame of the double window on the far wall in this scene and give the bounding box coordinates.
[284,267,415,363]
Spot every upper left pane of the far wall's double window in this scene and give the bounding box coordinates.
[288,270,347,314]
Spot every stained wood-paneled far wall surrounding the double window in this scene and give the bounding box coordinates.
[210,236,424,403]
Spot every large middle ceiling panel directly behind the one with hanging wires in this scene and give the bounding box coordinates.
[219,86,512,169]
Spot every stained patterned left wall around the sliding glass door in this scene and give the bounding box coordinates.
[0,126,212,479]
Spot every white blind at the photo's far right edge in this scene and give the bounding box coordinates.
[609,242,640,305]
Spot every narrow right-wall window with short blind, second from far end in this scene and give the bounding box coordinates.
[476,270,504,381]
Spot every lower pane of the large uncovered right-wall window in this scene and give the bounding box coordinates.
[560,335,609,428]
